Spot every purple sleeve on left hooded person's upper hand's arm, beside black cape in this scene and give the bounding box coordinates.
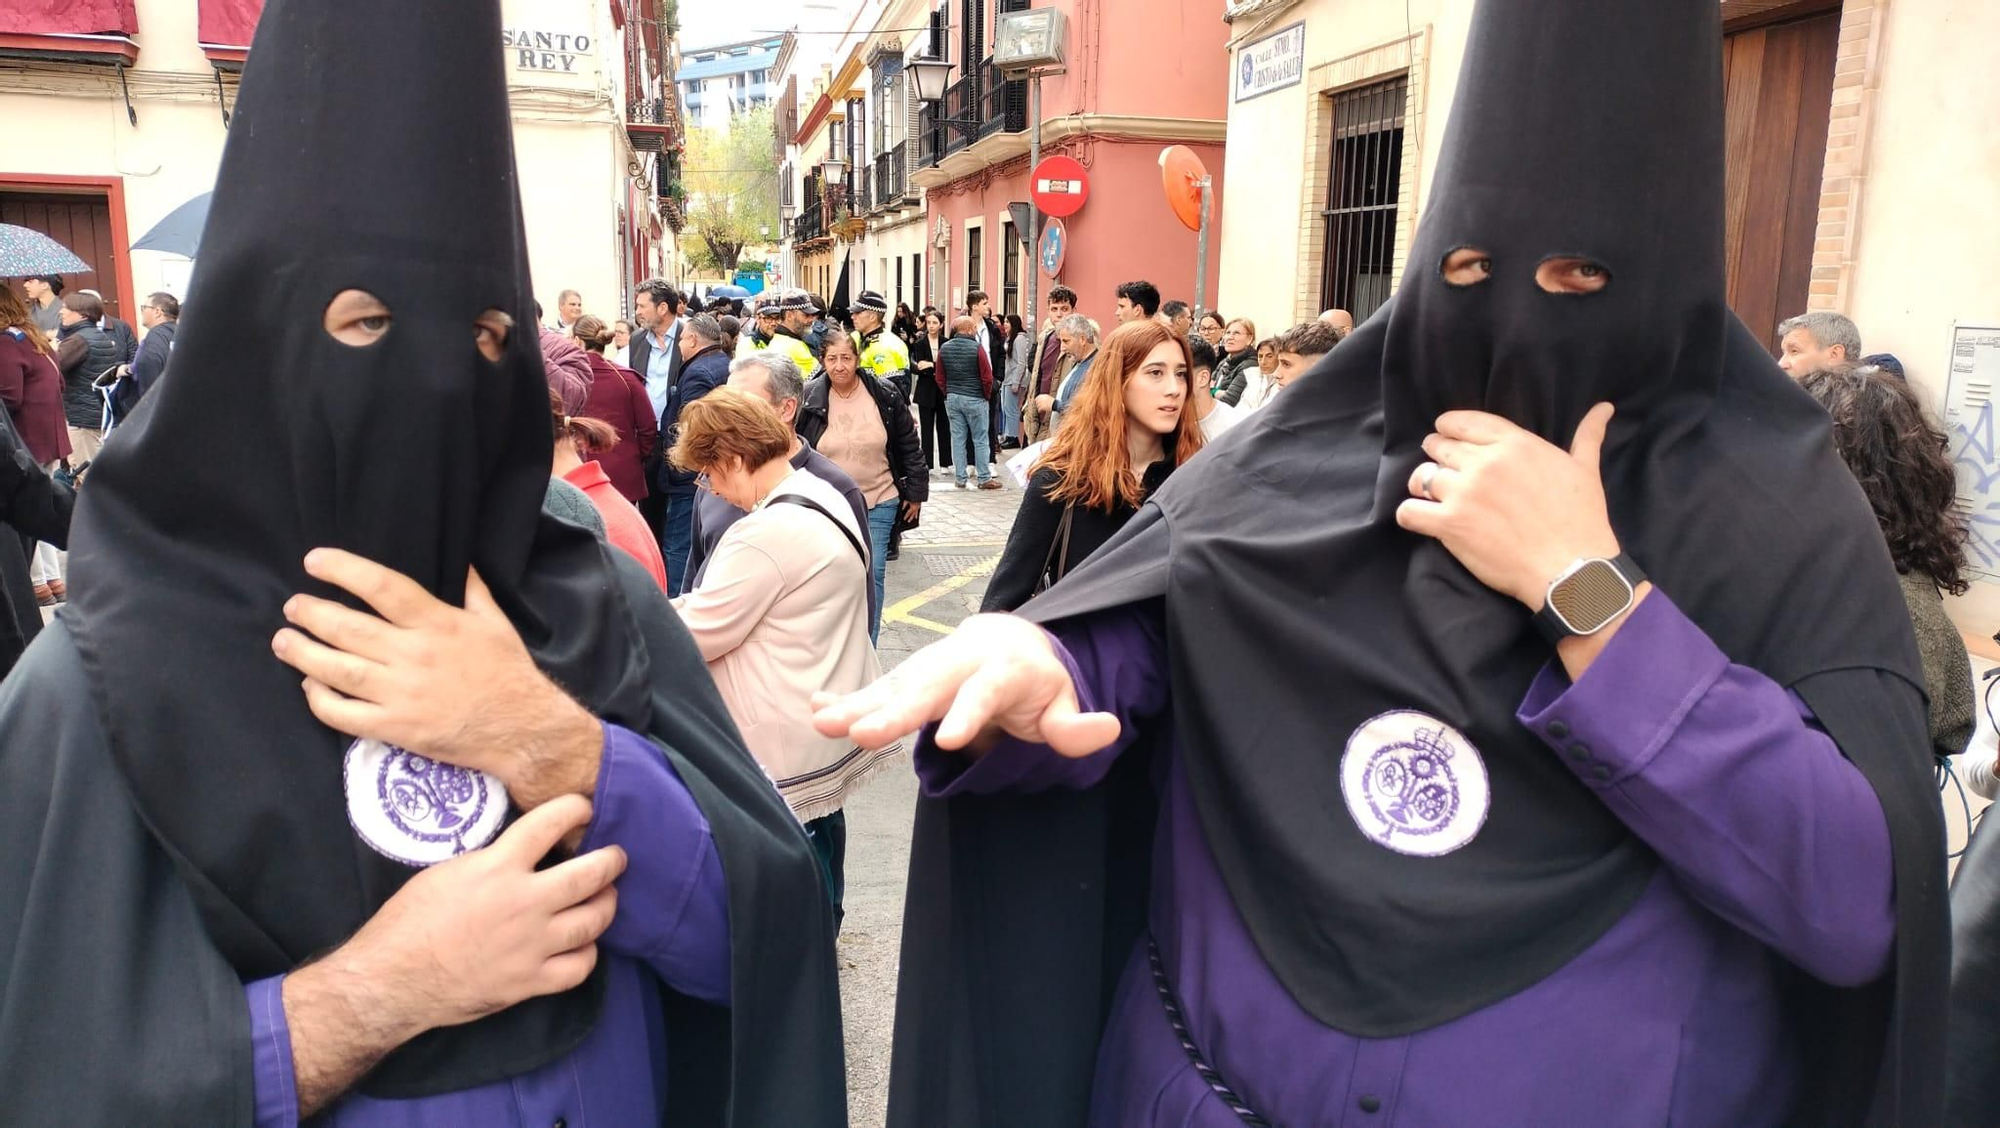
[580,724,730,1004]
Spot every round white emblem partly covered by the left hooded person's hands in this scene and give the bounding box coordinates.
[344,740,508,866]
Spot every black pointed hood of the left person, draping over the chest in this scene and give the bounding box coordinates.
[70,0,650,1096]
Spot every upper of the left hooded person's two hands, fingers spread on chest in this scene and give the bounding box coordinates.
[272,548,604,810]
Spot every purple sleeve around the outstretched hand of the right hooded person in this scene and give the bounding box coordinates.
[914,608,1168,798]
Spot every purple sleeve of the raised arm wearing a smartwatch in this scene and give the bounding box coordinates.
[1518,592,1896,986]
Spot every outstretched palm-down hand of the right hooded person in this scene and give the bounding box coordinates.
[812,614,1118,756]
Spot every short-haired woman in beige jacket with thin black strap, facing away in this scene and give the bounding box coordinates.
[668,388,902,920]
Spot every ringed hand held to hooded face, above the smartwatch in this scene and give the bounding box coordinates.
[1396,404,1618,610]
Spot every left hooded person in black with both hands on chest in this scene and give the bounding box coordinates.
[0,0,846,1124]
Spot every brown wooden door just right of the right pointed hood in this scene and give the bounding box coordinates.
[1722,10,1840,350]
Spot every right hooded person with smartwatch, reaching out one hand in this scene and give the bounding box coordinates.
[820,0,1944,1126]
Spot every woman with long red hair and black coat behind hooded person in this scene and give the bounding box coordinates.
[980,320,1202,612]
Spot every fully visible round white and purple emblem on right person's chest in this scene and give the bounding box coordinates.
[1340,710,1492,858]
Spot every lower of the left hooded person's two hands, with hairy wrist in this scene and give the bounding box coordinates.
[282,796,626,1118]
